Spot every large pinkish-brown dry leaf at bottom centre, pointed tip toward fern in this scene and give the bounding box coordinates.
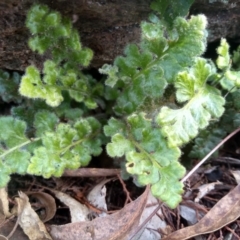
[50,187,149,240]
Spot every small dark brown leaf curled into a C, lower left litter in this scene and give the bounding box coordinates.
[26,192,57,222]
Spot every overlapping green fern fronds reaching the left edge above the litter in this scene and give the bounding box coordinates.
[0,110,102,187]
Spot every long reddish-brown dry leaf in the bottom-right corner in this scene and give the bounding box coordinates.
[163,184,240,240]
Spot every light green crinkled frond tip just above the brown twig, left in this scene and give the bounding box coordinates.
[27,118,101,178]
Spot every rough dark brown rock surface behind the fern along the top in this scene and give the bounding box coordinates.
[0,0,240,71]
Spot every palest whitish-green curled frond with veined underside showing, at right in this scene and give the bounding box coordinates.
[157,58,225,146]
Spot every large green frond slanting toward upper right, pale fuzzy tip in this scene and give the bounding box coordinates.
[100,15,207,115]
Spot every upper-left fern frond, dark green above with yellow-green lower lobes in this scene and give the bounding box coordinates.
[19,5,101,109]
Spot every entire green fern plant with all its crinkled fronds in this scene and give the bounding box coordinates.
[0,0,240,208]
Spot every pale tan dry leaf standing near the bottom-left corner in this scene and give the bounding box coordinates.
[16,192,52,240]
